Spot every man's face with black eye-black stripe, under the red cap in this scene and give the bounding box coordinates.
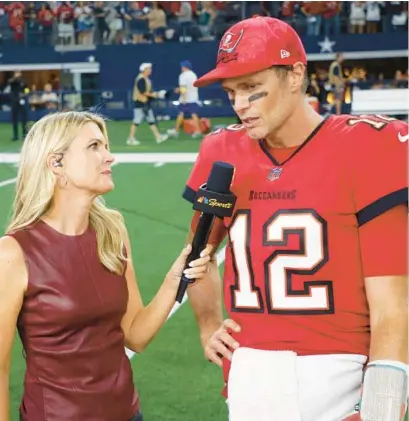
[222,69,300,139]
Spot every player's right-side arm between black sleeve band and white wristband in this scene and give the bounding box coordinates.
[359,205,408,363]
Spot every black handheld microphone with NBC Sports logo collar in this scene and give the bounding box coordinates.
[176,161,236,303]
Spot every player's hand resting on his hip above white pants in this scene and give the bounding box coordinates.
[204,319,241,367]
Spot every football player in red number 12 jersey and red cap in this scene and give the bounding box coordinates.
[183,17,408,421]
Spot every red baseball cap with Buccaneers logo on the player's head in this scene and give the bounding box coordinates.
[194,16,307,88]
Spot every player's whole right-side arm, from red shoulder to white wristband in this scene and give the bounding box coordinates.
[350,116,408,421]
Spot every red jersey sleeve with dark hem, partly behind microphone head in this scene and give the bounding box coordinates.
[182,133,223,203]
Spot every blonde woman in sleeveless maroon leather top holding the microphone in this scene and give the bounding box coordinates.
[0,112,209,421]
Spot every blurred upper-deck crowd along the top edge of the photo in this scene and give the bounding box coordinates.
[0,1,408,46]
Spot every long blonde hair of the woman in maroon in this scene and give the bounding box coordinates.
[7,111,126,275]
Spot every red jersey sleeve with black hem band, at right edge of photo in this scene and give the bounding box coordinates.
[350,116,408,226]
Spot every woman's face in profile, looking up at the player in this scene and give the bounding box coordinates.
[61,122,114,195]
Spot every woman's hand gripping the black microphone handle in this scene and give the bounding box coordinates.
[166,244,211,288]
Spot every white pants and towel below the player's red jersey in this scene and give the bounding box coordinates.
[228,348,367,421]
